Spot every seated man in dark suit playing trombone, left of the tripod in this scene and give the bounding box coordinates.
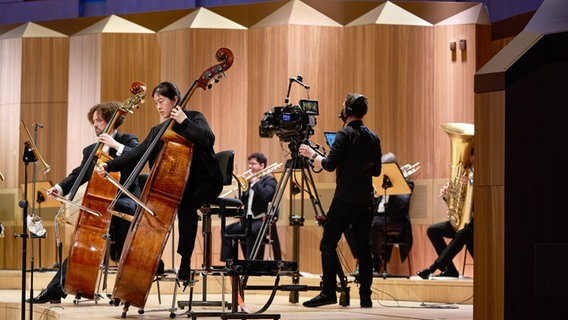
[221,152,282,261]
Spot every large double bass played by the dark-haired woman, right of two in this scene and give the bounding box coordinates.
[109,48,233,317]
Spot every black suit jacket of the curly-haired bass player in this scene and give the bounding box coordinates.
[59,132,139,195]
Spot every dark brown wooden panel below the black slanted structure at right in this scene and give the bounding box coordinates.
[474,91,505,319]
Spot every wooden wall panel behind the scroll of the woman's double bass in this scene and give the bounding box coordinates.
[156,28,248,169]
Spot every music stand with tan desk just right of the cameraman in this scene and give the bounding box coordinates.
[373,162,412,279]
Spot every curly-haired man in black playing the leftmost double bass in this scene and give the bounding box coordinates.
[26,102,140,303]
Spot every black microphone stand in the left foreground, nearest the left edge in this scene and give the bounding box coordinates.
[14,141,37,320]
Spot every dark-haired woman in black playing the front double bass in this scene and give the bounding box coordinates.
[96,81,223,283]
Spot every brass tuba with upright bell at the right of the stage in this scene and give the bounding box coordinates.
[440,123,474,231]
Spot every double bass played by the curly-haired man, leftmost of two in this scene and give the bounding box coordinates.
[56,82,146,299]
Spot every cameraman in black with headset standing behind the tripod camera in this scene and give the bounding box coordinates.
[299,93,381,308]
